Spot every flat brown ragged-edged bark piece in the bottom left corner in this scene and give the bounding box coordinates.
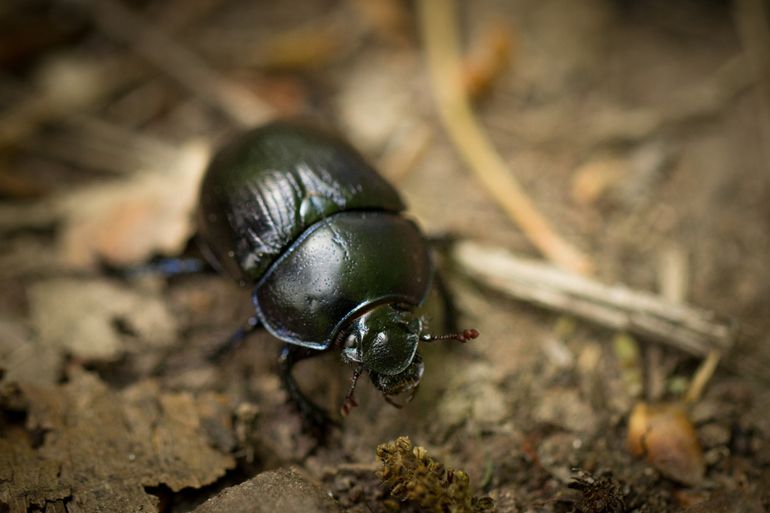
[0,371,235,513]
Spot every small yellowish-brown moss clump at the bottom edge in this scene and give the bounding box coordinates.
[377,436,495,513]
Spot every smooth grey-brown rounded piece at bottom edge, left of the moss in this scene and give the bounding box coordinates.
[193,468,341,513]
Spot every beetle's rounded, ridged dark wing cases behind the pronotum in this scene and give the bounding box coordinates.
[198,122,404,282]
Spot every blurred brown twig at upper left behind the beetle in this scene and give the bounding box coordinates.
[83,0,274,127]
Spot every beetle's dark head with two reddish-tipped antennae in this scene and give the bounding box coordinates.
[342,304,478,415]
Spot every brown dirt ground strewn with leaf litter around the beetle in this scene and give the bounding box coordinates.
[0,0,770,513]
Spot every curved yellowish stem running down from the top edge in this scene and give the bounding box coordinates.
[418,0,594,274]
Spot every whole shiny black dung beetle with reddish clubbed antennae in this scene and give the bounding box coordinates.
[197,121,478,427]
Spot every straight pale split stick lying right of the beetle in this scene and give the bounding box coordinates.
[452,241,735,356]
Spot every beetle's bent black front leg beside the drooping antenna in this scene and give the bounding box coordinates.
[278,344,336,439]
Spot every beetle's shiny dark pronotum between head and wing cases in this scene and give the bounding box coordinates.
[254,212,432,349]
